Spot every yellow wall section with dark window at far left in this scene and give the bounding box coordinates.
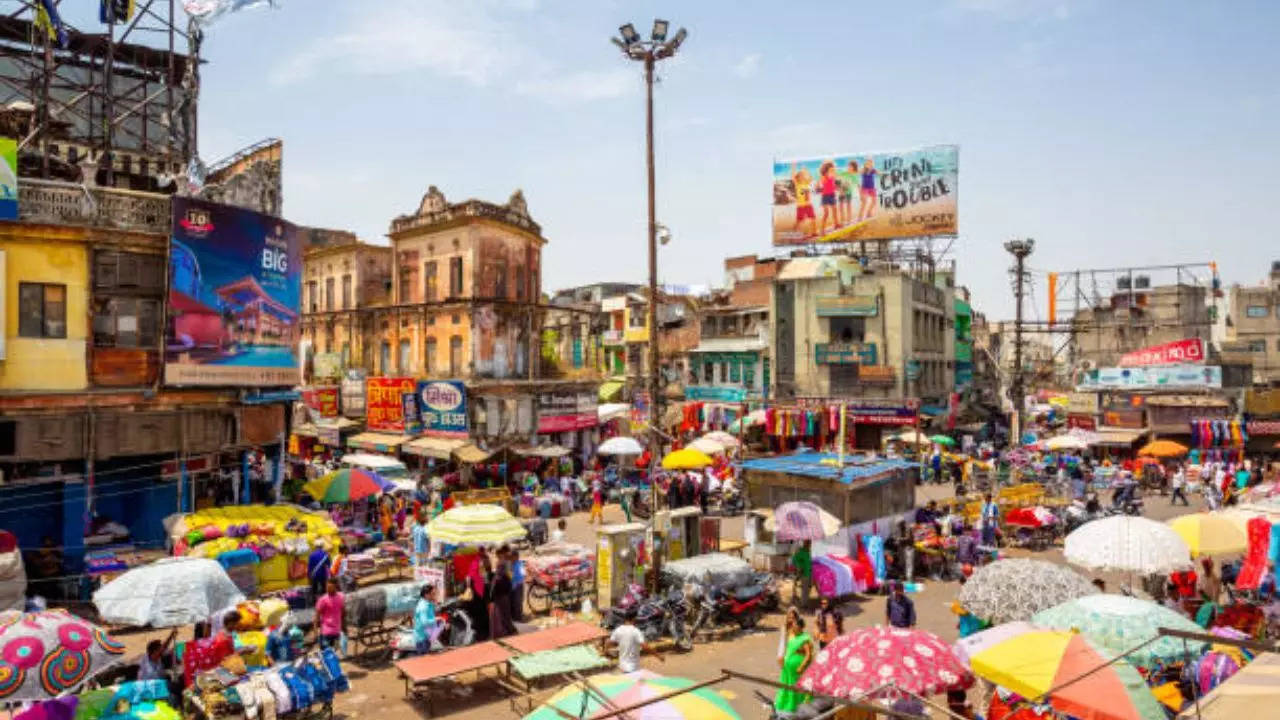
[0,223,88,391]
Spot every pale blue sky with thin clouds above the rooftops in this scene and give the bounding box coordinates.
[112,0,1280,319]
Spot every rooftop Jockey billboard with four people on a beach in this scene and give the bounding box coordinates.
[773,145,960,245]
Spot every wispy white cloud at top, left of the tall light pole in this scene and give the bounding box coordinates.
[270,0,635,101]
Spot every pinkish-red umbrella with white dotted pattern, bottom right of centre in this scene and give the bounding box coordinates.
[800,626,973,700]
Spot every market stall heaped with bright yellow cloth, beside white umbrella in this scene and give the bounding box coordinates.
[169,505,338,594]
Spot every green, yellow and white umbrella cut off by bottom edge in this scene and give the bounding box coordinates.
[524,670,741,720]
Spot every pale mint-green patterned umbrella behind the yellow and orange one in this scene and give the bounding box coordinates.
[1032,594,1204,667]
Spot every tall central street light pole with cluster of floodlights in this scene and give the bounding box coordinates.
[612,19,689,591]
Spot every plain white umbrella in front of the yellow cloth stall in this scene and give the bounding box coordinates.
[93,557,244,628]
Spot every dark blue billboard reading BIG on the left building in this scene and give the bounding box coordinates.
[164,197,302,387]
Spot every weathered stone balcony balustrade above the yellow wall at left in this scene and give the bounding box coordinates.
[18,178,173,234]
